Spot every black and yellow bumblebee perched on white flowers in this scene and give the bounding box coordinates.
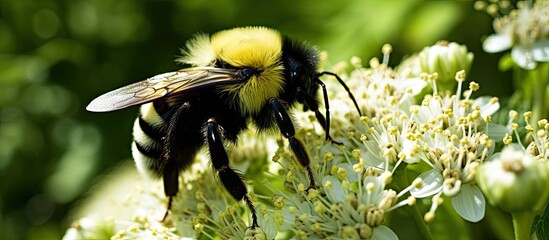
[86,27,360,227]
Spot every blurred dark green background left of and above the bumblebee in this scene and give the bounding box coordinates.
[0,0,513,239]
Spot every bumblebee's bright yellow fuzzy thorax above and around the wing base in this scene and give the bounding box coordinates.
[178,27,284,115]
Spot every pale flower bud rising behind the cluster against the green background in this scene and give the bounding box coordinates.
[419,41,473,91]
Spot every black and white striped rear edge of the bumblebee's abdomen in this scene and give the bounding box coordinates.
[132,103,166,177]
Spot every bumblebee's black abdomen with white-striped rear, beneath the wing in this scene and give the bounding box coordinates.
[132,91,246,177]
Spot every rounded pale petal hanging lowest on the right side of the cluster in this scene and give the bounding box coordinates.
[452,184,486,222]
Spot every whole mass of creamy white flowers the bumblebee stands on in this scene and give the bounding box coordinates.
[65,40,549,239]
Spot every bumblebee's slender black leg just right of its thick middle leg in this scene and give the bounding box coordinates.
[269,98,315,188]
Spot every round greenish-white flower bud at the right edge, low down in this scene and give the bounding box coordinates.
[476,147,549,212]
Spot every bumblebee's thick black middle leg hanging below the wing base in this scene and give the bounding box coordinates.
[206,118,258,228]
